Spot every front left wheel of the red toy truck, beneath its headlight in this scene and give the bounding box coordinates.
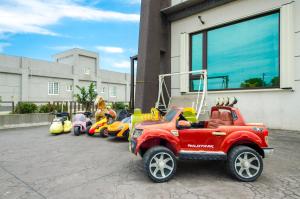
[143,146,177,182]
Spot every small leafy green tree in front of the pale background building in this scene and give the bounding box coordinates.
[74,83,97,111]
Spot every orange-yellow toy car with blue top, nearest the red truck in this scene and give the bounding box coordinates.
[107,117,131,138]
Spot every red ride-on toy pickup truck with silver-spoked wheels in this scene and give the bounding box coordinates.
[130,106,273,182]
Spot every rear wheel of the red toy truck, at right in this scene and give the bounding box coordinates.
[227,146,263,182]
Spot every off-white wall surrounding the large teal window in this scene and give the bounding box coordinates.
[171,0,300,130]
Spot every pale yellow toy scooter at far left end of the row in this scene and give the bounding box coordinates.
[49,112,72,134]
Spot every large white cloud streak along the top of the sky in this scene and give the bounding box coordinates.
[0,0,139,36]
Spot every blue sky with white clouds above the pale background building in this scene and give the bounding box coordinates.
[0,0,140,72]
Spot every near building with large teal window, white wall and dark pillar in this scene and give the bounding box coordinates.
[136,0,300,130]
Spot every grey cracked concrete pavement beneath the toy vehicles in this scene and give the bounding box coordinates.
[0,126,300,199]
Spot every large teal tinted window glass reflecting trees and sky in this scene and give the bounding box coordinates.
[191,13,279,90]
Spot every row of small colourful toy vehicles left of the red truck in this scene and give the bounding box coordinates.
[49,97,131,138]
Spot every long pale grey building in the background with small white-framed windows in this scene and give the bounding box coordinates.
[0,48,130,102]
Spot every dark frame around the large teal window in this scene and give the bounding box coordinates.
[189,9,281,92]
